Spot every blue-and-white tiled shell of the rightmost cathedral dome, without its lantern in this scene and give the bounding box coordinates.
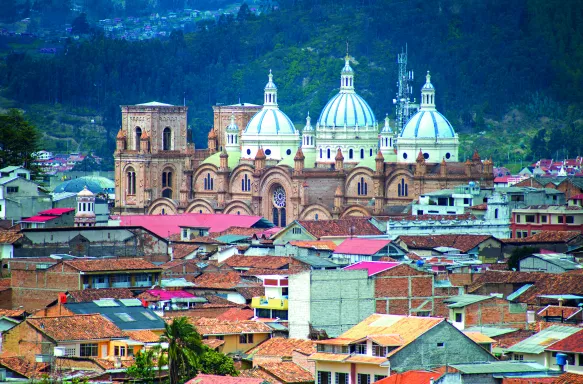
[400,110,455,139]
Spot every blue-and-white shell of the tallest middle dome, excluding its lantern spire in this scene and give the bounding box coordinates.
[318,92,376,127]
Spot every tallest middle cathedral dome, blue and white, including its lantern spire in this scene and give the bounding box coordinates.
[318,57,377,127]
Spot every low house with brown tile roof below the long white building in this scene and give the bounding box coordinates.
[394,235,502,261]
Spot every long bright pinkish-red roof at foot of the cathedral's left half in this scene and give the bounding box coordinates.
[119,213,262,238]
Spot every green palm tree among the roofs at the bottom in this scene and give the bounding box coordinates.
[160,317,203,384]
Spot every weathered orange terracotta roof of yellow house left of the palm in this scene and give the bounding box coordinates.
[26,314,124,341]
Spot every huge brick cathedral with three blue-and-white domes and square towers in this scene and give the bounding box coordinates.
[114,57,493,226]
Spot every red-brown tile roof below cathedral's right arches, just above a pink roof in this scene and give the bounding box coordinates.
[298,217,383,239]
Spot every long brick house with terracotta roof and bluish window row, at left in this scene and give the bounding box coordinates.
[11,258,162,309]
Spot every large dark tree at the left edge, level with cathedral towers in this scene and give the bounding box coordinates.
[0,109,39,172]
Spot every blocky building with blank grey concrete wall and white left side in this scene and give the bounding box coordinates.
[288,270,375,338]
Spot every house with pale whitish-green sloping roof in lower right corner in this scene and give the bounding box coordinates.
[506,325,581,368]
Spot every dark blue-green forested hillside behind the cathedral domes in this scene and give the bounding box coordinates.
[0,0,583,160]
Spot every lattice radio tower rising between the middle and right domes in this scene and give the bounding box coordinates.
[393,45,419,134]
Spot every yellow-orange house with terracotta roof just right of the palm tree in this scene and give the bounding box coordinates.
[191,318,272,354]
